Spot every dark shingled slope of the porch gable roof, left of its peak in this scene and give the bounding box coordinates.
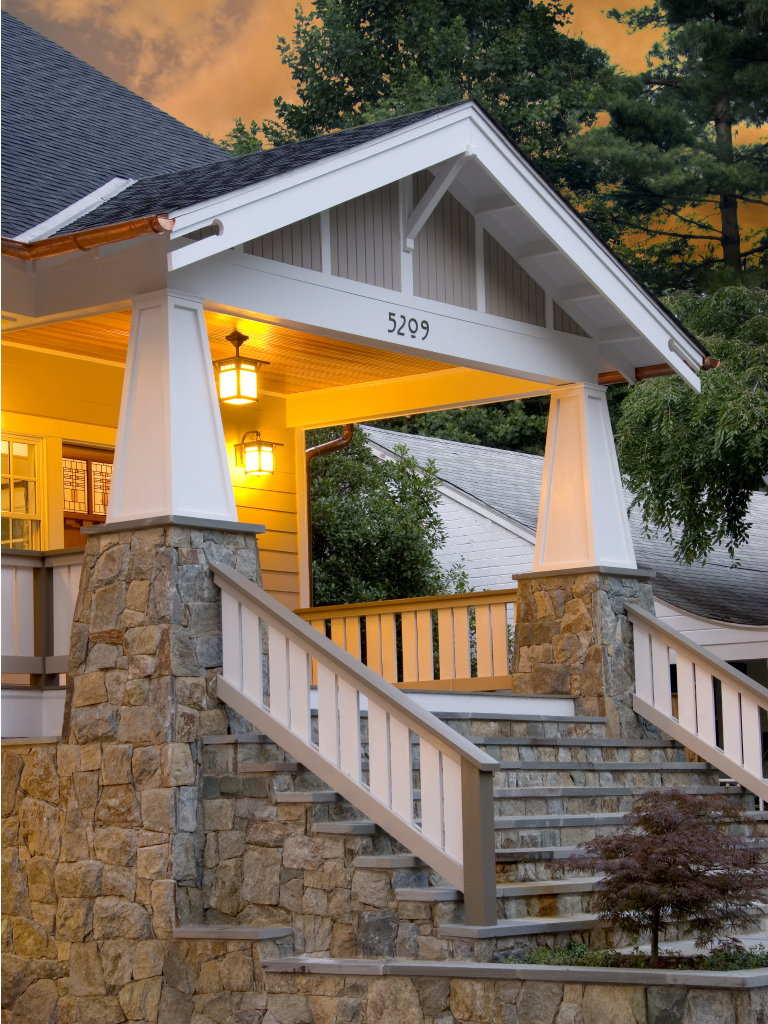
[54,103,461,232]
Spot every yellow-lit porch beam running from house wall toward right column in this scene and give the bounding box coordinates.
[286,367,549,430]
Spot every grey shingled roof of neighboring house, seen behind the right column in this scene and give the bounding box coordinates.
[365,426,768,626]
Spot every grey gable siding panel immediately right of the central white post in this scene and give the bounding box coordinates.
[414,171,477,309]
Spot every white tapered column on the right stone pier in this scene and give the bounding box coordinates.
[534,384,637,572]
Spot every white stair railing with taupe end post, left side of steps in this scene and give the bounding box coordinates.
[213,564,498,925]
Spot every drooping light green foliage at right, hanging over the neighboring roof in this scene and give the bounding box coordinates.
[615,286,768,563]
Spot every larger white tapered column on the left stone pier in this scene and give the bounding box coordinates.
[106,290,238,522]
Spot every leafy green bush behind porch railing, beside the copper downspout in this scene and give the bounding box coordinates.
[307,428,466,605]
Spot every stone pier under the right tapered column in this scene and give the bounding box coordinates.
[512,570,655,738]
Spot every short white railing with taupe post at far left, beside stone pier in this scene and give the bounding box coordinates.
[0,548,83,684]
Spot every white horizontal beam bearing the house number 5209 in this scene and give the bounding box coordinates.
[174,249,597,385]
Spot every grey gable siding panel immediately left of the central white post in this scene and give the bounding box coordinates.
[331,181,400,292]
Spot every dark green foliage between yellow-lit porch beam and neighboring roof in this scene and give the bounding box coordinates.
[372,396,549,455]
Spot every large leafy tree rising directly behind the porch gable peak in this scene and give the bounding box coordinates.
[224,0,611,176]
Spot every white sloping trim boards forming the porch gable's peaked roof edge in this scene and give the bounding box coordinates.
[168,100,701,391]
